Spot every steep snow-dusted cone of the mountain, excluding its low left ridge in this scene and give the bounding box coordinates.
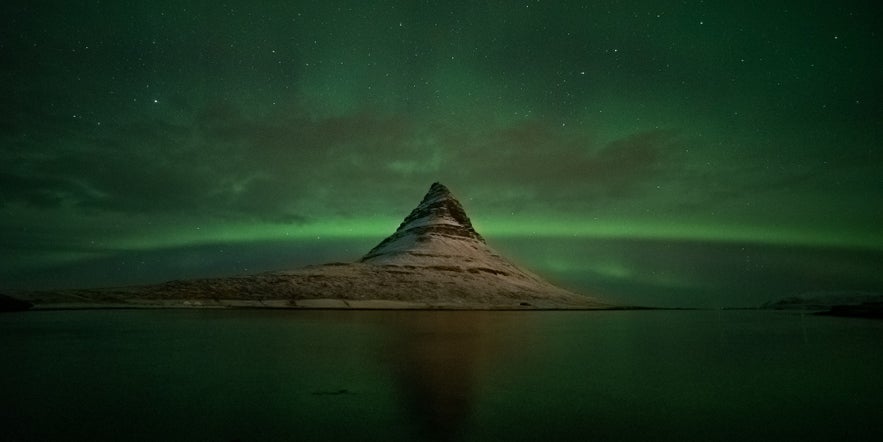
[348,183,597,305]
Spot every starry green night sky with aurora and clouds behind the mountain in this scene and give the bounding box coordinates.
[0,0,883,307]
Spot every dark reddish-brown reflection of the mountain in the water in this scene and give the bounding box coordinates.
[388,311,512,440]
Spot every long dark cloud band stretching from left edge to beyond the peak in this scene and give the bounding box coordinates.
[0,91,682,228]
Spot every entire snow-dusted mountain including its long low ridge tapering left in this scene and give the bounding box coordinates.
[3,183,615,310]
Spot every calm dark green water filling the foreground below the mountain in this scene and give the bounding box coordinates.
[0,310,883,441]
